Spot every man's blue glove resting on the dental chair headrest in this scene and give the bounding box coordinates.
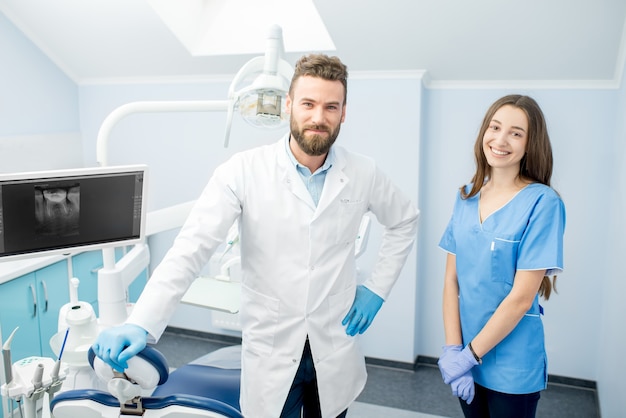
[91,324,148,373]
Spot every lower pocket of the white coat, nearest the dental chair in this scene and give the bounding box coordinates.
[240,284,280,356]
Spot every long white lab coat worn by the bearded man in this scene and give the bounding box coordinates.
[128,138,418,418]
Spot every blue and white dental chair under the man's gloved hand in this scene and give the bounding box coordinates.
[50,346,243,418]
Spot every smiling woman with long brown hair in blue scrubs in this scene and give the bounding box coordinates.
[439,95,565,418]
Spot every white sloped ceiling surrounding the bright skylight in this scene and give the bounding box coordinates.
[0,0,626,87]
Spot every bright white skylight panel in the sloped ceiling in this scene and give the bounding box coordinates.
[148,0,335,56]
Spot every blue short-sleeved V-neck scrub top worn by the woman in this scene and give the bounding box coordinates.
[439,183,565,394]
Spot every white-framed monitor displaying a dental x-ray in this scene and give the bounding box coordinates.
[0,165,147,261]
